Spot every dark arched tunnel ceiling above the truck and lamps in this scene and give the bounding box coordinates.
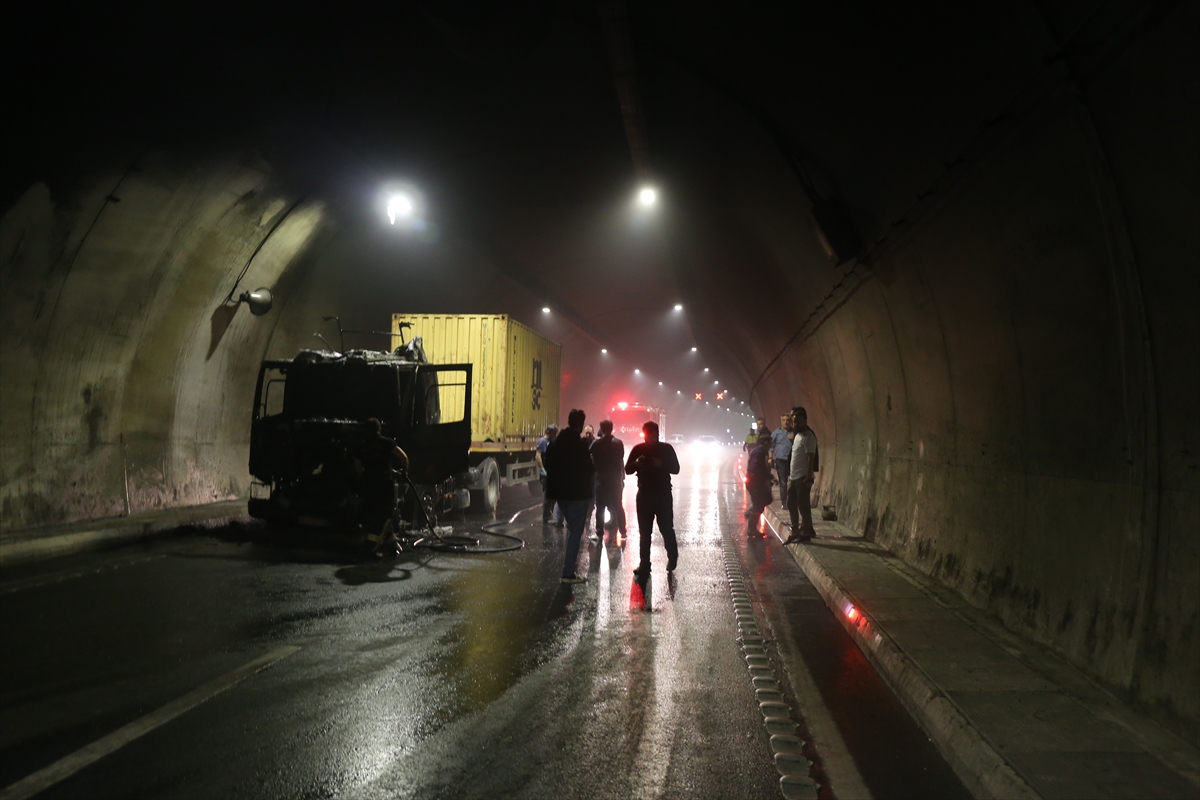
[5,4,1089,412]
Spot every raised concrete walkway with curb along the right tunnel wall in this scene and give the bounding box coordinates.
[767,503,1200,800]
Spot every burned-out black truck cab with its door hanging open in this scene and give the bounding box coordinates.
[248,339,472,530]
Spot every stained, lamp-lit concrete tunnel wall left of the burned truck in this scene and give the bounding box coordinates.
[0,152,322,531]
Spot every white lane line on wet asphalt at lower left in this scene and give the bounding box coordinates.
[0,646,300,800]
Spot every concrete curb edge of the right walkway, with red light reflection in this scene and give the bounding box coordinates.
[767,507,1042,800]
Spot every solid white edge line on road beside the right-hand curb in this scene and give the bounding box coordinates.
[763,515,871,800]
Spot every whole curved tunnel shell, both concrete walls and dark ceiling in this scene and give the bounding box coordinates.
[0,0,1200,742]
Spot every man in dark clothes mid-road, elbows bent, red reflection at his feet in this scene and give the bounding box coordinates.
[625,422,679,578]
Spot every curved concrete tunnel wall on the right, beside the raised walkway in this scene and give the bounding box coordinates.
[748,8,1200,741]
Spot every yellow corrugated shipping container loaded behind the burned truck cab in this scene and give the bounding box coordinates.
[391,314,563,461]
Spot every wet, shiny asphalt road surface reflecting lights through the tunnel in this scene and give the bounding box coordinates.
[0,453,967,798]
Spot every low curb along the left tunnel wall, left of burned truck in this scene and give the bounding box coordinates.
[0,500,250,567]
